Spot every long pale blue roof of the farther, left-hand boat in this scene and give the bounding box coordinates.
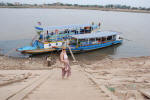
[35,24,97,31]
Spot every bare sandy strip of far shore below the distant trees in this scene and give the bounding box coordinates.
[0,6,150,13]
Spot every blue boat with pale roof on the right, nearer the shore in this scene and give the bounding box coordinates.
[56,31,123,53]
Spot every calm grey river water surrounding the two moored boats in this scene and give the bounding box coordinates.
[0,8,150,60]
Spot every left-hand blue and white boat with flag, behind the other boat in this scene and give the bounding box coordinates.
[17,23,100,54]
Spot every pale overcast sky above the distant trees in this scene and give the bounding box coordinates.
[0,0,150,7]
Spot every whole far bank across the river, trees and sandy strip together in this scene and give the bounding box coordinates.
[0,2,150,13]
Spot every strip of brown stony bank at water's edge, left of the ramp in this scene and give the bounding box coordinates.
[0,56,55,70]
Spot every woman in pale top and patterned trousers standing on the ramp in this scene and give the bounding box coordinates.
[60,47,71,79]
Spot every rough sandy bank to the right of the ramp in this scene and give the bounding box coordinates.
[83,57,150,100]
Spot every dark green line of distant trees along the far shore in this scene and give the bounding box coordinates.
[0,2,150,11]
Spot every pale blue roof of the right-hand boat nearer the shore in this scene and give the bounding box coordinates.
[71,31,121,39]
